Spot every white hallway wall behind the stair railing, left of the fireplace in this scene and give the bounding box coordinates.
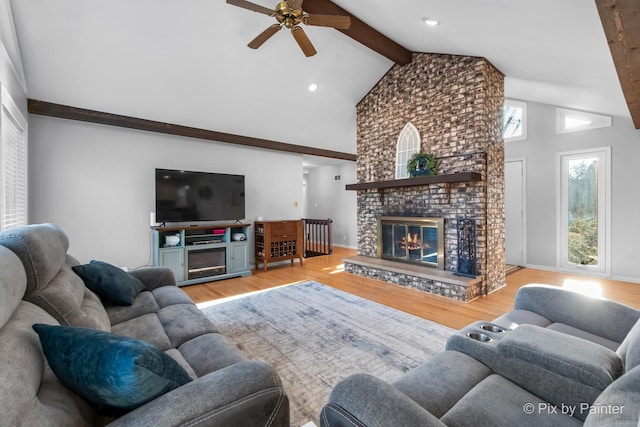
[305,162,358,249]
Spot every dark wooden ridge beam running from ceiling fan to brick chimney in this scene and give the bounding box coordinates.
[303,0,412,65]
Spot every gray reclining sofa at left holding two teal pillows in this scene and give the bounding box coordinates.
[0,224,289,426]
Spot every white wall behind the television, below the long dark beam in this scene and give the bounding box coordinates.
[29,115,303,268]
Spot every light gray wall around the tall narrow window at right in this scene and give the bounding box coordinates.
[505,102,640,282]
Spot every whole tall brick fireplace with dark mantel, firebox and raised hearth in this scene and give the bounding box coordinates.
[344,53,505,301]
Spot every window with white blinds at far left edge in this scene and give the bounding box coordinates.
[0,88,28,230]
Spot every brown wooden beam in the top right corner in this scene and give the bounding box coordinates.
[595,0,640,129]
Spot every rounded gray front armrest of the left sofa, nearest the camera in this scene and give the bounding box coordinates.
[109,360,289,427]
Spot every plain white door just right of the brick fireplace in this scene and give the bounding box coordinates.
[504,160,525,266]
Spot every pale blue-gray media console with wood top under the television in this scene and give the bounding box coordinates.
[151,224,251,286]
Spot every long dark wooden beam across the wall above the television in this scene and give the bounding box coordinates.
[28,99,356,162]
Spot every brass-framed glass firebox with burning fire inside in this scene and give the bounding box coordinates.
[378,217,444,270]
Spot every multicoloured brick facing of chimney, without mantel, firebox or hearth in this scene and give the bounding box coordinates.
[350,53,505,294]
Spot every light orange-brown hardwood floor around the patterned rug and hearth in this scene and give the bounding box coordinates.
[182,247,640,329]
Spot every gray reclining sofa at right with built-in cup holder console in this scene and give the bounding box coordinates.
[321,285,640,427]
